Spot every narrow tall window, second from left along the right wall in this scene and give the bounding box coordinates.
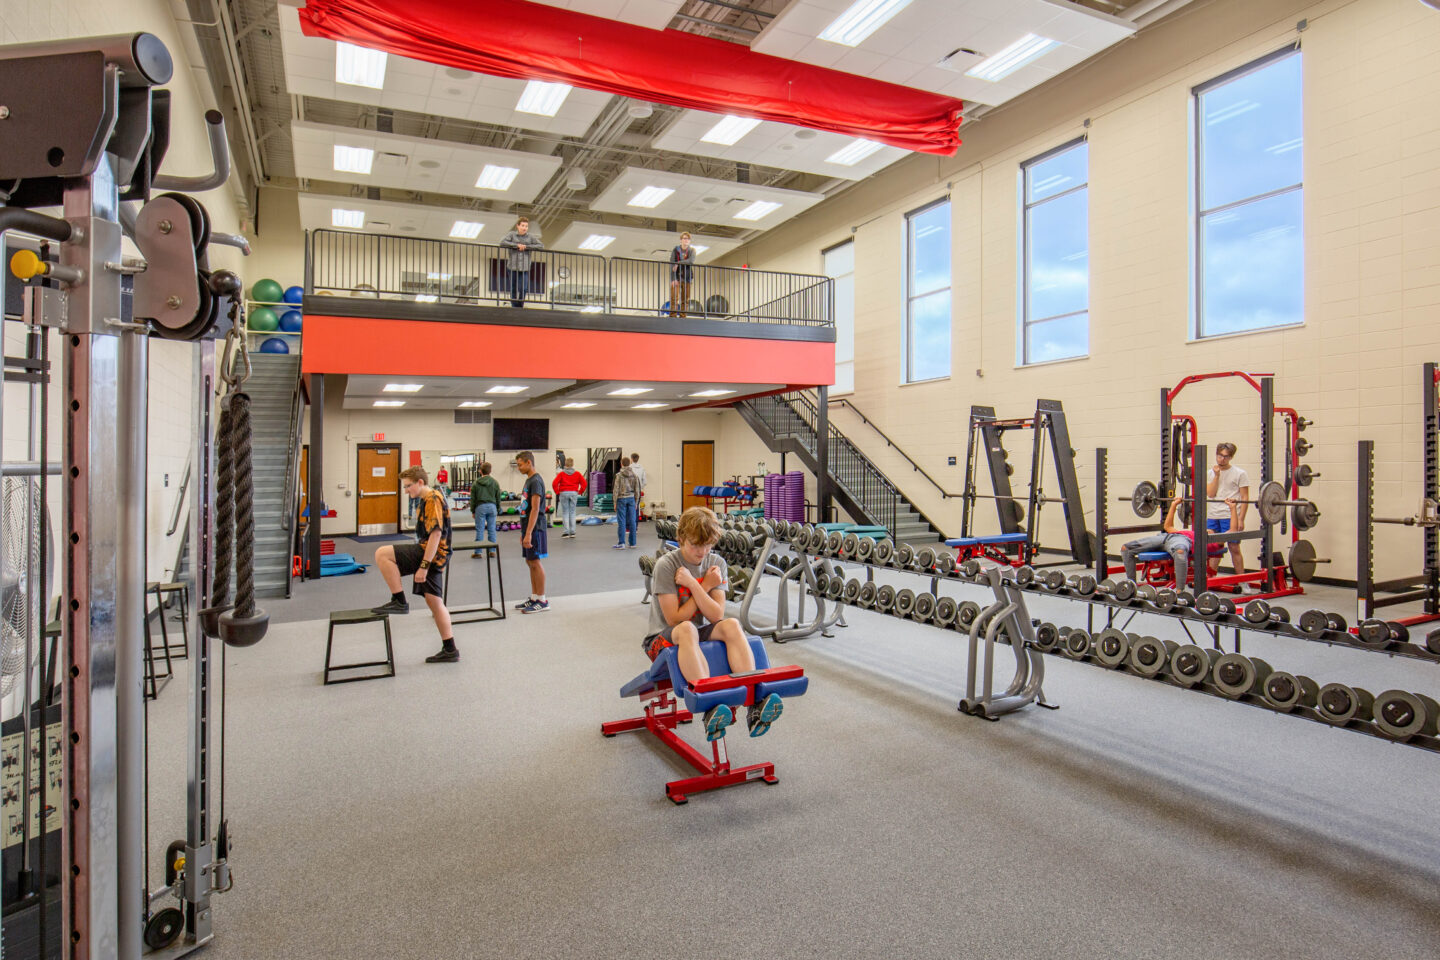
[904,199,950,383]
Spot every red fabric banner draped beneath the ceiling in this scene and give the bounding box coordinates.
[300,0,963,155]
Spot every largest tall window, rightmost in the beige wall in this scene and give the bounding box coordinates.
[1195,50,1305,337]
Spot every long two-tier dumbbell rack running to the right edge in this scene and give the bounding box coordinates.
[792,543,1440,753]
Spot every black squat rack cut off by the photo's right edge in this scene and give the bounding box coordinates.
[1355,363,1440,626]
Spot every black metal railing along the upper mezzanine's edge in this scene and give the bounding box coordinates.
[305,230,834,327]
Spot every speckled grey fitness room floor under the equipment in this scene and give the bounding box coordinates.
[150,524,1440,960]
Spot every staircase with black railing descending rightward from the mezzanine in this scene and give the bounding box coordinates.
[734,394,945,543]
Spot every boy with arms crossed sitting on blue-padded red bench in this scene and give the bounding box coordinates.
[641,507,783,740]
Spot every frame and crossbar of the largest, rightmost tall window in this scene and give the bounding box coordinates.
[1189,48,1305,343]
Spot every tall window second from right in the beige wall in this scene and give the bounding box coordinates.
[1017,140,1090,364]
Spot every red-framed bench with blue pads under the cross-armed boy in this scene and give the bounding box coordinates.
[600,636,809,805]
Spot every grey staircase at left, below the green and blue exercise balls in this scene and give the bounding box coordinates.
[245,353,300,597]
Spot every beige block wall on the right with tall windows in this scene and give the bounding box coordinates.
[729,0,1440,587]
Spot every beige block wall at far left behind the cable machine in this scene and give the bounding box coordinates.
[0,0,251,579]
